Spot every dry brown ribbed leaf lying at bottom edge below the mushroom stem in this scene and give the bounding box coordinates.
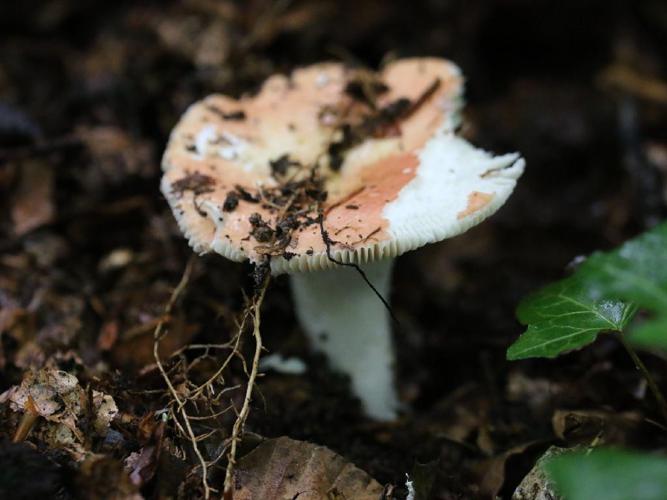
[234,437,383,500]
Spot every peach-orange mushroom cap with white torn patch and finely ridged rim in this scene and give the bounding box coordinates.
[161,58,524,274]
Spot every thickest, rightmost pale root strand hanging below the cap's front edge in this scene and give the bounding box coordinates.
[223,275,271,500]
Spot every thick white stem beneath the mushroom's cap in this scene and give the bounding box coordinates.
[291,259,398,420]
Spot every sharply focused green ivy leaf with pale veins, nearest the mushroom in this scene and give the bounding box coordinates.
[507,276,635,360]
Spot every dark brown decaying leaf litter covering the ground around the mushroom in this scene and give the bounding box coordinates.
[0,1,665,498]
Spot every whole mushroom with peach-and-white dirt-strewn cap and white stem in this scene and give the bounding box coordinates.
[161,58,524,420]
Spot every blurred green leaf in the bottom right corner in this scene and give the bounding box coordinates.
[546,449,667,500]
